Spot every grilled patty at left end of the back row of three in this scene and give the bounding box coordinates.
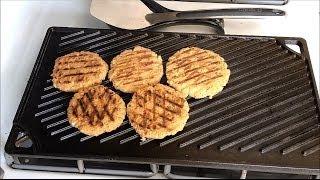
[51,51,108,92]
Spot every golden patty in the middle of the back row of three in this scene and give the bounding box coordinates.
[109,46,163,93]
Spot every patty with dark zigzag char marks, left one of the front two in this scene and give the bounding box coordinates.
[67,85,126,136]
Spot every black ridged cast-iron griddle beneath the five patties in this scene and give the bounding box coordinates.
[5,27,320,174]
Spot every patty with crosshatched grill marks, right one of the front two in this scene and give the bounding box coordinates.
[127,84,189,139]
